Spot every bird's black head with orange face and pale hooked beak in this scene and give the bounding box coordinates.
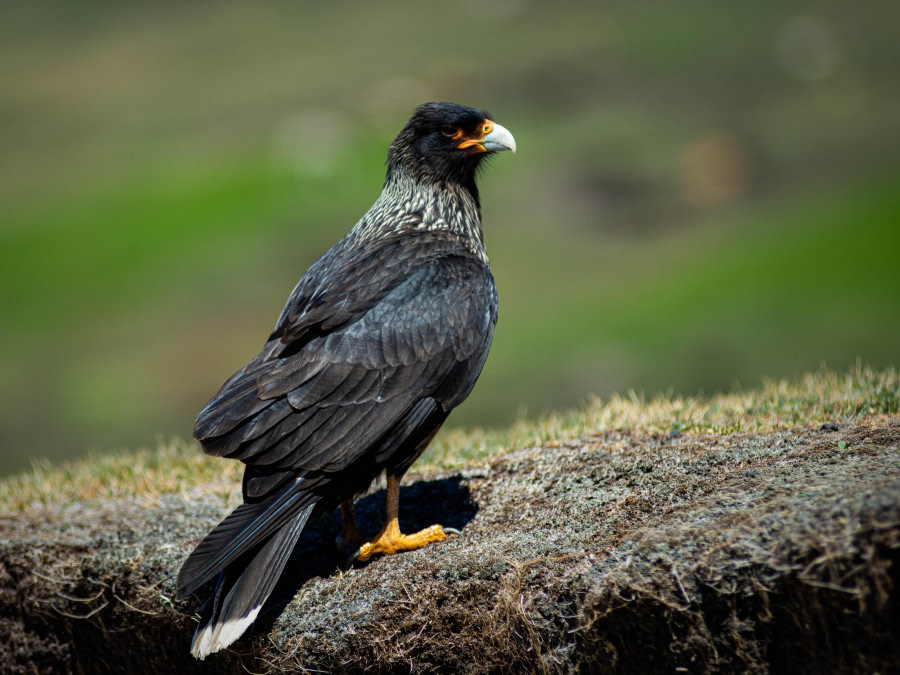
[388,103,516,195]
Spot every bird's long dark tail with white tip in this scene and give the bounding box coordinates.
[177,479,319,659]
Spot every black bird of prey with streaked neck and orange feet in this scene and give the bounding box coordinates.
[176,102,516,660]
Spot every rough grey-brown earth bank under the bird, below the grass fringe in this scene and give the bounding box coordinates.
[0,416,900,673]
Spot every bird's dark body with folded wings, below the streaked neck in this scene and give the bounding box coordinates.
[194,231,497,501]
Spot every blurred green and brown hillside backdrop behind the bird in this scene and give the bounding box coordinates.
[0,0,900,472]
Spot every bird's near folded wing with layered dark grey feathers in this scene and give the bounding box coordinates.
[197,256,496,472]
